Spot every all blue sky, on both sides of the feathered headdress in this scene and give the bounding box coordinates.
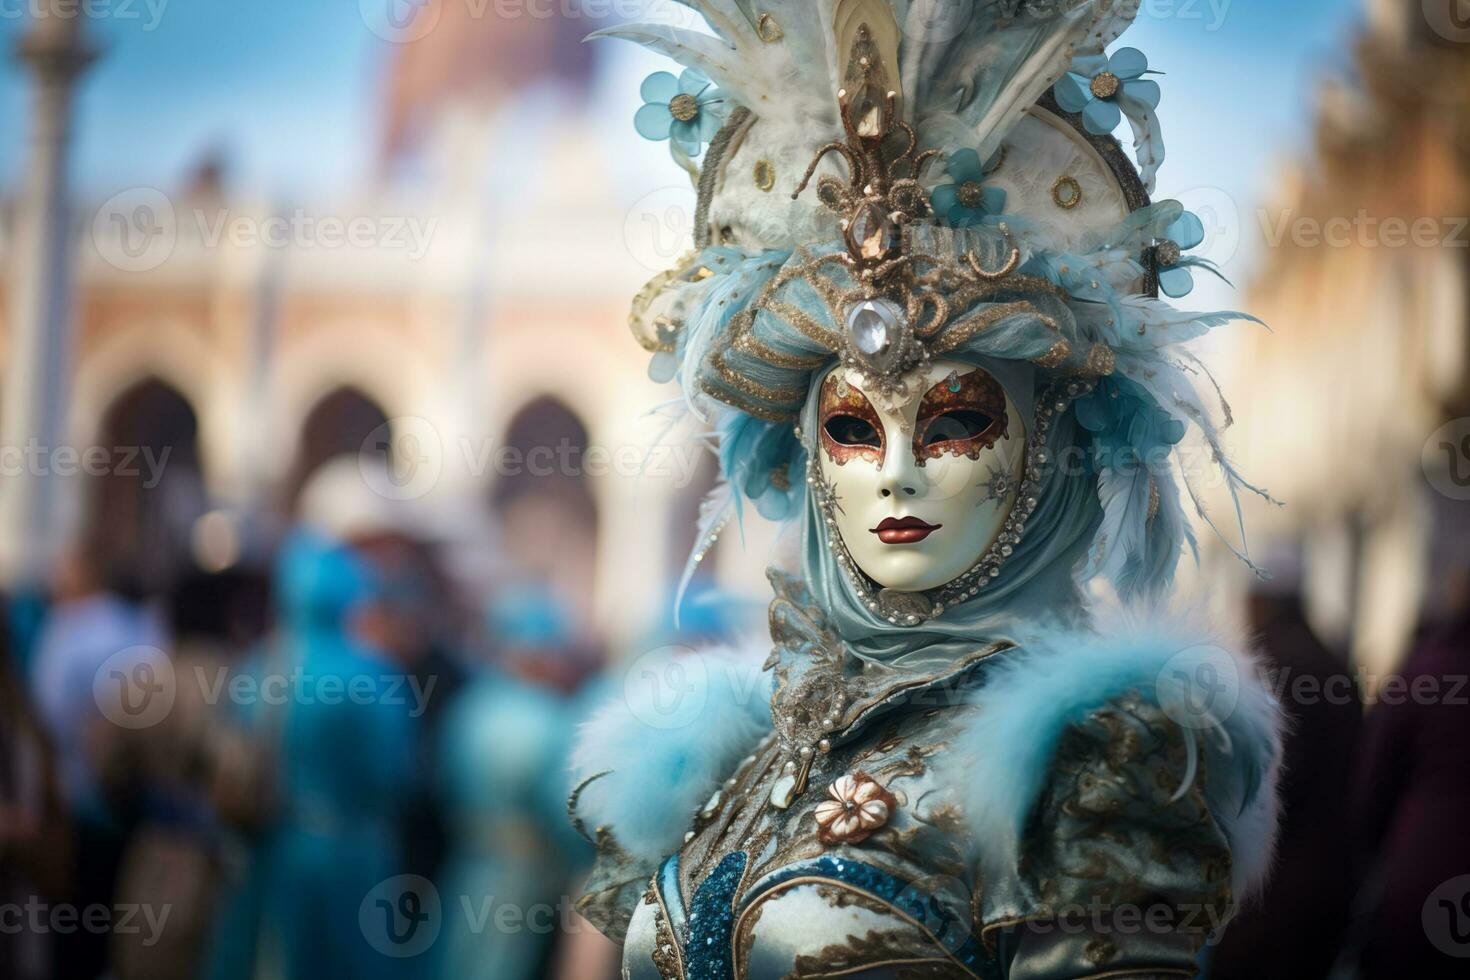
[0,0,1361,298]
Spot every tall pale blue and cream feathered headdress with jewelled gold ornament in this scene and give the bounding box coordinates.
[600,0,1264,617]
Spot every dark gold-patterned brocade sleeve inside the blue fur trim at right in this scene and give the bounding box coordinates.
[1010,693,1232,980]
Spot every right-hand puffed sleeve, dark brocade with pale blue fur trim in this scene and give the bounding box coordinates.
[946,624,1280,980]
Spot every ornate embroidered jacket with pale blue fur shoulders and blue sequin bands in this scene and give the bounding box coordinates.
[572,574,1279,980]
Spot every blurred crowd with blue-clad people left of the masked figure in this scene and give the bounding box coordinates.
[0,457,643,980]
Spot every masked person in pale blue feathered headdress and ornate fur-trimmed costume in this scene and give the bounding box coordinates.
[572,0,1279,980]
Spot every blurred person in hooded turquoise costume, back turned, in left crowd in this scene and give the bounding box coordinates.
[210,529,417,980]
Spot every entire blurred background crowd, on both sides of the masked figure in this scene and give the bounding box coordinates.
[0,458,1470,980]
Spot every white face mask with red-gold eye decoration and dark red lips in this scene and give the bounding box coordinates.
[817,360,1028,592]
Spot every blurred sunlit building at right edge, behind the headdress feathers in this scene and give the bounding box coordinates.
[1227,0,1470,674]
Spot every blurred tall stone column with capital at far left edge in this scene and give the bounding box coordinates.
[0,10,94,585]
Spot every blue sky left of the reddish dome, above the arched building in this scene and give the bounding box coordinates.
[0,0,388,195]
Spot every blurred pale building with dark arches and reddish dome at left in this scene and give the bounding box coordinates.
[0,4,732,652]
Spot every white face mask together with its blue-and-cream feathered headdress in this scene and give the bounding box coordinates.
[612,0,1270,630]
